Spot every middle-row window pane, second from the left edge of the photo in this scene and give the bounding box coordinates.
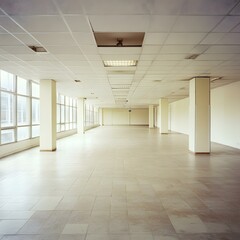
[17,96,29,125]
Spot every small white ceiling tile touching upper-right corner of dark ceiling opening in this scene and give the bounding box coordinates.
[148,15,177,32]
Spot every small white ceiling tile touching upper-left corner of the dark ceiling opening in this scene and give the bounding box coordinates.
[64,15,92,32]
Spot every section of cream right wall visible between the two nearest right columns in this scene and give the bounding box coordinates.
[170,98,189,134]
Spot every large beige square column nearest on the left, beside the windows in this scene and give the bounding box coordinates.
[40,80,57,151]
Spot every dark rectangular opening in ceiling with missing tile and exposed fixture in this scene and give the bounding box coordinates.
[94,32,145,47]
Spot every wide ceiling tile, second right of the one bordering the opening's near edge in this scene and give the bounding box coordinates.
[172,16,223,33]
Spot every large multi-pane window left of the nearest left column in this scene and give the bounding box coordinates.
[0,70,40,144]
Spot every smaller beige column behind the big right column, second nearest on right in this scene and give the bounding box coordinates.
[158,98,168,134]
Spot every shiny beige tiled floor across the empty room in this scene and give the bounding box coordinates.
[0,127,240,240]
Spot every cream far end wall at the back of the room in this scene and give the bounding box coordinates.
[103,108,148,126]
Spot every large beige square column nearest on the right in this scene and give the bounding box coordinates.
[189,77,210,153]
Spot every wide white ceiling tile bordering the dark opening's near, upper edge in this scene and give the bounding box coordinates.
[89,15,149,32]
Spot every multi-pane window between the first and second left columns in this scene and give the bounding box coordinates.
[57,93,77,132]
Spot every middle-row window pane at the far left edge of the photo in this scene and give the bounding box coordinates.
[1,92,15,127]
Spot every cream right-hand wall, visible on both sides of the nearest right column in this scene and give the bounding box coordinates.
[170,82,240,149]
